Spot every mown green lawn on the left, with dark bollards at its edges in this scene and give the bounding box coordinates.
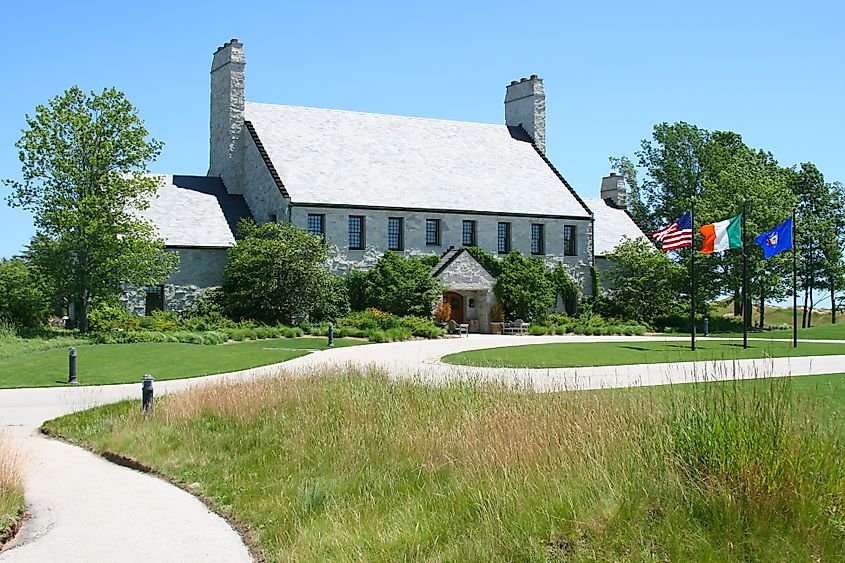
[0,338,362,388]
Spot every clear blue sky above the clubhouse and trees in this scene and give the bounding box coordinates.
[0,0,845,256]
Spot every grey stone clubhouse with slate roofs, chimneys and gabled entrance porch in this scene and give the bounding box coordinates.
[124,39,643,332]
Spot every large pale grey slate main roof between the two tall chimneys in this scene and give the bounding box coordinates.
[244,102,589,219]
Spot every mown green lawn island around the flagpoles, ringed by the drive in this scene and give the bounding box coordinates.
[443,339,845,368]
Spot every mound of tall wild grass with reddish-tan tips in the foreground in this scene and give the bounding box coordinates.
[46,372,845,561]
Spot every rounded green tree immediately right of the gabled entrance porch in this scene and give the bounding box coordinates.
[493,251,557,322]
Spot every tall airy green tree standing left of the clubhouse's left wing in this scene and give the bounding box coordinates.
[4,86,178,332]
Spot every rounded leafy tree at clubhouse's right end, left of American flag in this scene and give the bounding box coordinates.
[600,239,689,325]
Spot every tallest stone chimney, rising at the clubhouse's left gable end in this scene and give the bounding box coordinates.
[208,39,246,194]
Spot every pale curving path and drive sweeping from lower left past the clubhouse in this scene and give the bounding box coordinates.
[0,335,845,563]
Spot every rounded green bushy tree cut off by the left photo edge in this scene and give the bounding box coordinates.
[0,258,50,328]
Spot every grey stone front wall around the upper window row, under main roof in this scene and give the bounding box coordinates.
[290,206,592,295]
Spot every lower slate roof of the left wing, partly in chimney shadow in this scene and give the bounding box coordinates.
[135,174,251,248]
